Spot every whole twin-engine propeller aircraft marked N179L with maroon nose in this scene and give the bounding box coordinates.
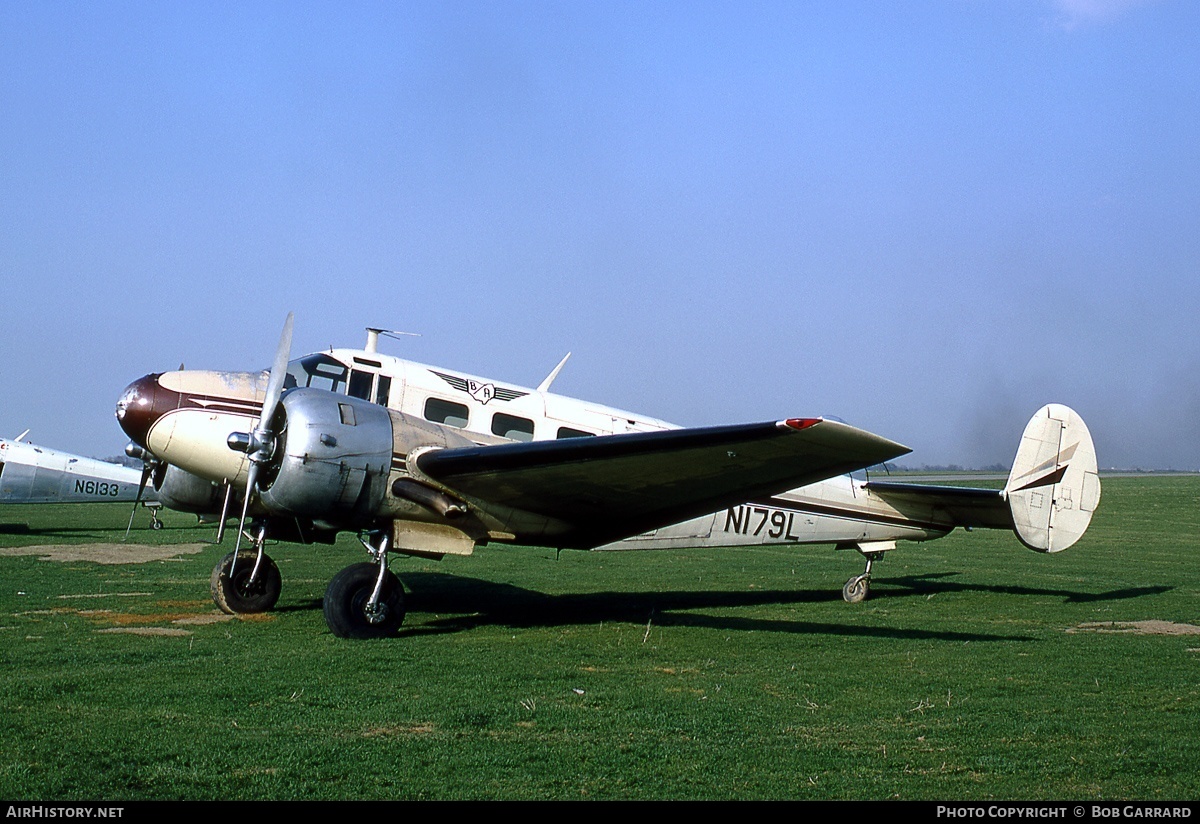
[116,315,1100,638]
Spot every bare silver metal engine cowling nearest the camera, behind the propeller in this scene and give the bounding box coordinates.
[259,389,392,528]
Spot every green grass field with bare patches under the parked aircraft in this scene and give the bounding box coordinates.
[0,476,1200,800]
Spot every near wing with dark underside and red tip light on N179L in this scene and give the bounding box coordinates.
[415,419,910,548]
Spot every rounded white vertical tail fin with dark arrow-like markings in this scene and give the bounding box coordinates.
[1004,403,1100,552]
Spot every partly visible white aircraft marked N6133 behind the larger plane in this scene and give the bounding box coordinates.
[0,429,162,529]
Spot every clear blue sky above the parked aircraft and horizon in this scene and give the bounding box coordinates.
[0,0,1200,469]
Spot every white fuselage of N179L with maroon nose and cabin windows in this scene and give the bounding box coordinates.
[110,338,954,554]
